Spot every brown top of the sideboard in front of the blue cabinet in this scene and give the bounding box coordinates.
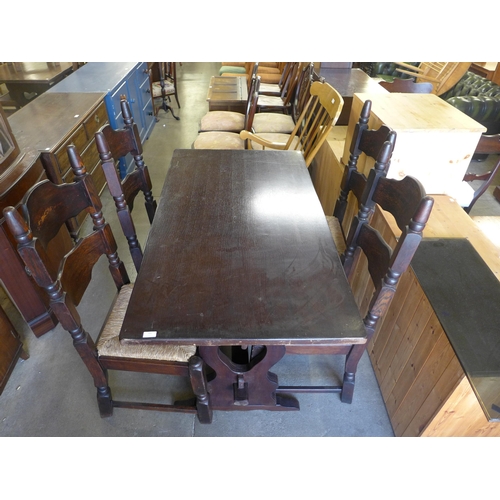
[8,92,106,152]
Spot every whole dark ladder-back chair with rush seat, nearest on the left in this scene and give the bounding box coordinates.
[3,146,211,422]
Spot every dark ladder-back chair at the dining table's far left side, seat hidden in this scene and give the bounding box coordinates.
[95,96,156,271]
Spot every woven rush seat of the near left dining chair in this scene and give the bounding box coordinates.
[97,284,196,362]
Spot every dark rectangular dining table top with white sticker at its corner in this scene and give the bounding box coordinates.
[120,150,365,346]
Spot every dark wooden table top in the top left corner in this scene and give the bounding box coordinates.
[0,62,73,84]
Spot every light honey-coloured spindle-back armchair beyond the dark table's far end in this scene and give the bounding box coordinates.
[240,82,344,167]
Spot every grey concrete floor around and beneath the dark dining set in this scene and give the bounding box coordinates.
[0,63,500,437]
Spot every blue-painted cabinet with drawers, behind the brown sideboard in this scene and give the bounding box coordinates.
[49,62,155,177]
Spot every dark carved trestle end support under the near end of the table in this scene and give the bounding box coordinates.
[199,345,299,411]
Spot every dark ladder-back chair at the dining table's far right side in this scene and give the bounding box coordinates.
[326,99,397,253]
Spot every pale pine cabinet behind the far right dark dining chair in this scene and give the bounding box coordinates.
[342,93,486,199]
